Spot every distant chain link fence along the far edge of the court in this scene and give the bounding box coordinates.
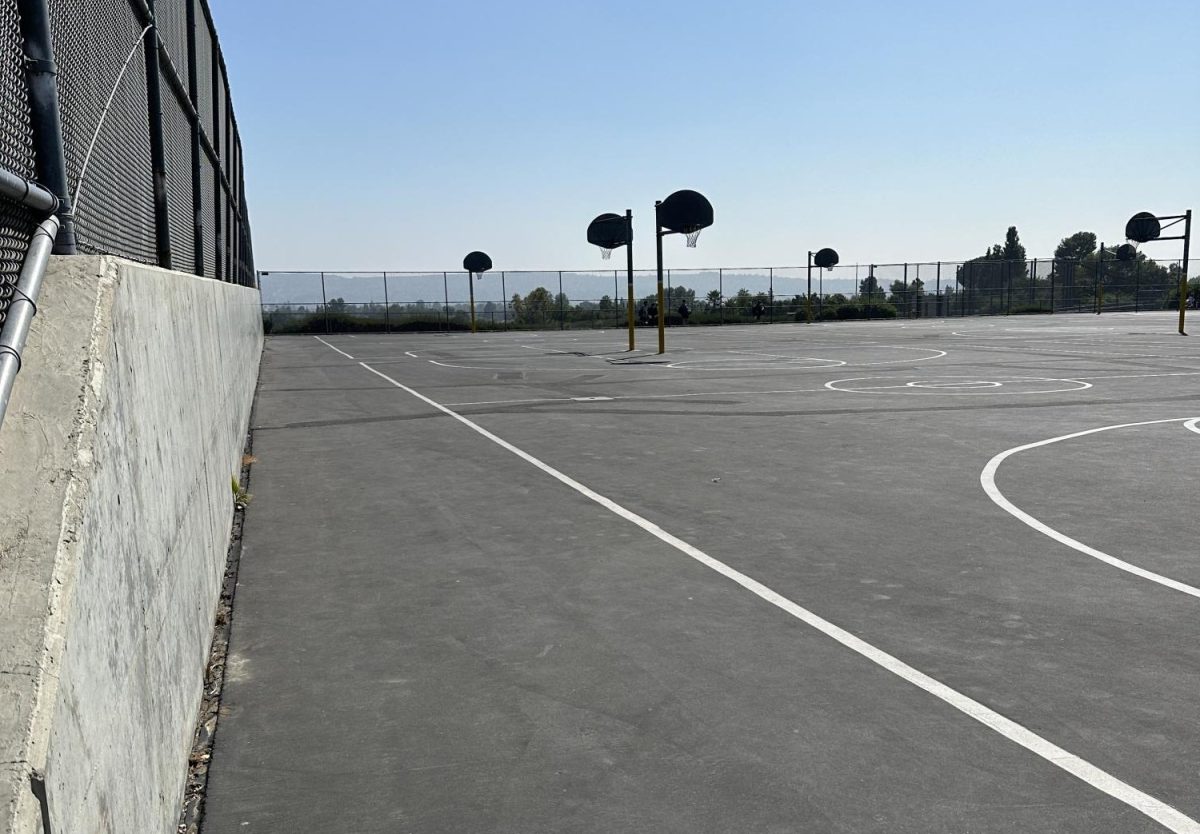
[259,253,1200,334]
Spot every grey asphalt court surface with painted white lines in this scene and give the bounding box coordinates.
[204,313,1200,834]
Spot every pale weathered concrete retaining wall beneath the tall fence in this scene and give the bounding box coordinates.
[0,257,263,834]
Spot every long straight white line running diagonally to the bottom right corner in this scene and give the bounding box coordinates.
[343,362,1200,834]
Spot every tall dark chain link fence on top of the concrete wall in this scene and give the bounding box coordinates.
[0,0,256,324]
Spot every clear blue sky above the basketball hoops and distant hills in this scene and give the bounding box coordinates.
[211,0,1200,270]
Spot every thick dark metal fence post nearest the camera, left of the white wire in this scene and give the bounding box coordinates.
[17,0,78,254]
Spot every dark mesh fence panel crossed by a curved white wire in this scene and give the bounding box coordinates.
[50,0,157,263]
